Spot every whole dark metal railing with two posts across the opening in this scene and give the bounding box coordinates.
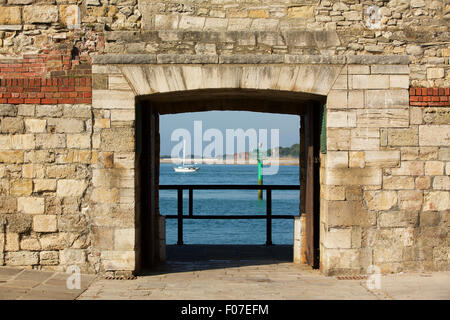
[159,184,300,245]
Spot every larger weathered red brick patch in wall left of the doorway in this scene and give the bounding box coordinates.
[0,51,92,104]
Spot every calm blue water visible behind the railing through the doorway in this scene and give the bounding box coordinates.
[159,163,299,244]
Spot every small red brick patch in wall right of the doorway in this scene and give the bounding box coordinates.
[409,88,450,107]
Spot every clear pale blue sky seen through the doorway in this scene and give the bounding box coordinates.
[159,111,300,155]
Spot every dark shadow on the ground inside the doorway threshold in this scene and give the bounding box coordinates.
[139,244,293,276]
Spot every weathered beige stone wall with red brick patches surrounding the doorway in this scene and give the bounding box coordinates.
[0,0,450,274]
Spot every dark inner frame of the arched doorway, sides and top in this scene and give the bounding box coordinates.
[136,89,325,268]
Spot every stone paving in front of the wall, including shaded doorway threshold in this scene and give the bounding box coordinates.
[0,245,450,300]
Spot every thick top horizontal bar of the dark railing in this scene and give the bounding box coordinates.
[159,184,300,190]
